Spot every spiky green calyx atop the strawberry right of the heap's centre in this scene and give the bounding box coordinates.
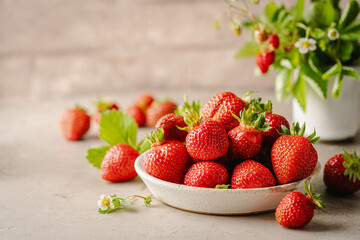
[231,108,271,132]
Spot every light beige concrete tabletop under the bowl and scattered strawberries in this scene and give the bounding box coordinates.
[0,90,360,240]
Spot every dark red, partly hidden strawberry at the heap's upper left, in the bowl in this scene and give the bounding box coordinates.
[155,113,187,142]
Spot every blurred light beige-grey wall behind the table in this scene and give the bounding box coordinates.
[0,0,294,102]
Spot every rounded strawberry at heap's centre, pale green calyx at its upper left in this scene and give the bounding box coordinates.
[184,111,229,161]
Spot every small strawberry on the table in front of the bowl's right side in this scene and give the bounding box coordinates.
[275,183,325,228]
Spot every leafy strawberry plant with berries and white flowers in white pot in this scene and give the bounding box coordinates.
[215,0,360,110]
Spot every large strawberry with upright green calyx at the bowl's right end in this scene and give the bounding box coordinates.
[271,123,319,184]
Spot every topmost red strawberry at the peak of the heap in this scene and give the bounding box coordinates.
[201,92,245,132]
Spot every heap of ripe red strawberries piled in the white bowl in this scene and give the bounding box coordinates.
[144,92,318,191]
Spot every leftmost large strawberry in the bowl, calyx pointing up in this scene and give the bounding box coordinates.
[144,129,189,184]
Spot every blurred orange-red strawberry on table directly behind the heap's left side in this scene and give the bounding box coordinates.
[146,100,177,127]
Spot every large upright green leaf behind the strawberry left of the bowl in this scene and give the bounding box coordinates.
[100,110,138,148]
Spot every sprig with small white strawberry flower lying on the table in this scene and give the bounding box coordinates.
[97,194,152,214]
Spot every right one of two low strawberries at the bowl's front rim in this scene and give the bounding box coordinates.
[231,160,276,189]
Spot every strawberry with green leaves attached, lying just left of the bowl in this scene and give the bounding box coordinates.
[86,109,150,182]
